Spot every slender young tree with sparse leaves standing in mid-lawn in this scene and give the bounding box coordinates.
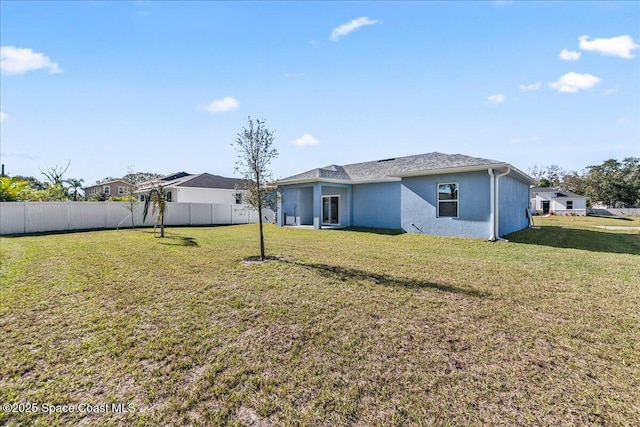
[234,117,278,261]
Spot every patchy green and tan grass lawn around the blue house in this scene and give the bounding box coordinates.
[0,217,640,426]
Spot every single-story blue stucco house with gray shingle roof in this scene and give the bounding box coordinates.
[277,153,535,240]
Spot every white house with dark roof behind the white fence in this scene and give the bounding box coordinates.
[136,172,246,205]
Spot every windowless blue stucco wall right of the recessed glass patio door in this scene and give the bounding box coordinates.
[353,182,400,229]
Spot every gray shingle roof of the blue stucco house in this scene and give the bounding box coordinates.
[279,152,505,183]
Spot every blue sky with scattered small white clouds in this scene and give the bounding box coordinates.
[0,0,640,184]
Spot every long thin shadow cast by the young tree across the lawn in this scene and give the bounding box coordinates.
[281,259,491,298]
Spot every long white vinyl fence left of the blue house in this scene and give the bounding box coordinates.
[0,202,274,234]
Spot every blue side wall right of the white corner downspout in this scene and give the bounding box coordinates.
[498,176,529,237]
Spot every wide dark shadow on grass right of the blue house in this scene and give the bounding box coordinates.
[506,226,640,255]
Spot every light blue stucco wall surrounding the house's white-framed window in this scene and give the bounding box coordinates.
[401,172,492,238]
